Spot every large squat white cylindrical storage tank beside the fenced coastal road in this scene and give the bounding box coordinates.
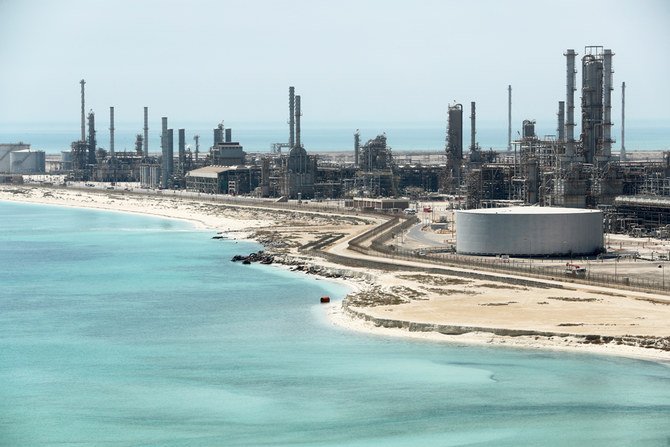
[456,206,604,256]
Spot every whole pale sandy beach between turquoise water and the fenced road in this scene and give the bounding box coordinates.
[0,185,670,362]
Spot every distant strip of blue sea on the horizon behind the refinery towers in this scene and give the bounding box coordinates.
[0,121,670,154]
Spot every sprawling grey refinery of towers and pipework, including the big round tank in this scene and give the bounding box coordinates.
[0,46,670,248]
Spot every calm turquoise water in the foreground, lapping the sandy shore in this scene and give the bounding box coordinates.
[0,202,670,447]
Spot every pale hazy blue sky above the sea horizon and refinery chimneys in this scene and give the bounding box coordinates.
[0,0,670,129]
